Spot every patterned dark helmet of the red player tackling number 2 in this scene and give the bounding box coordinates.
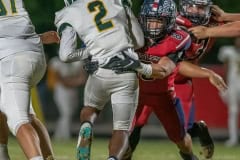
[139,0,176,42]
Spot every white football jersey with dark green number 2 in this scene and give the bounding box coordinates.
[55,0,140,60]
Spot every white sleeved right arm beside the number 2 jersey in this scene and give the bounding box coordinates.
[125,7,144,49]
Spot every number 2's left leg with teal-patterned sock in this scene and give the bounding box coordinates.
[77,75,110,160]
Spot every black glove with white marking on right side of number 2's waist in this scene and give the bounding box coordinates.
[111,52,141,74]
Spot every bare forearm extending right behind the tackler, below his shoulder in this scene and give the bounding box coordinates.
[179,61,212,78]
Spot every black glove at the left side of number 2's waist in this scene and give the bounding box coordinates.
[83,56,98,74]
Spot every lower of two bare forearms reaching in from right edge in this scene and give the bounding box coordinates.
[206,21,240,37]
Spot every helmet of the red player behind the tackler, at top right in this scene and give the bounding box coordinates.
[179,0,212,25]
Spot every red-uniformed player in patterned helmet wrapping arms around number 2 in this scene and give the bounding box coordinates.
[124,0,197,160]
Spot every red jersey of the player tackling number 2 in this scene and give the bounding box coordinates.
[139,29,191,95]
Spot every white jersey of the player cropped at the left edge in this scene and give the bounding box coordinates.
[0,0,43,58]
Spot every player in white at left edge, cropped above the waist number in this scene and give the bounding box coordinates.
[0,0,46,160]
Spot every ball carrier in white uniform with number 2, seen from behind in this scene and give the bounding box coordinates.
[55,0,167,160]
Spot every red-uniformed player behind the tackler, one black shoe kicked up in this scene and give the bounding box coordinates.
[175,0,219,158]
